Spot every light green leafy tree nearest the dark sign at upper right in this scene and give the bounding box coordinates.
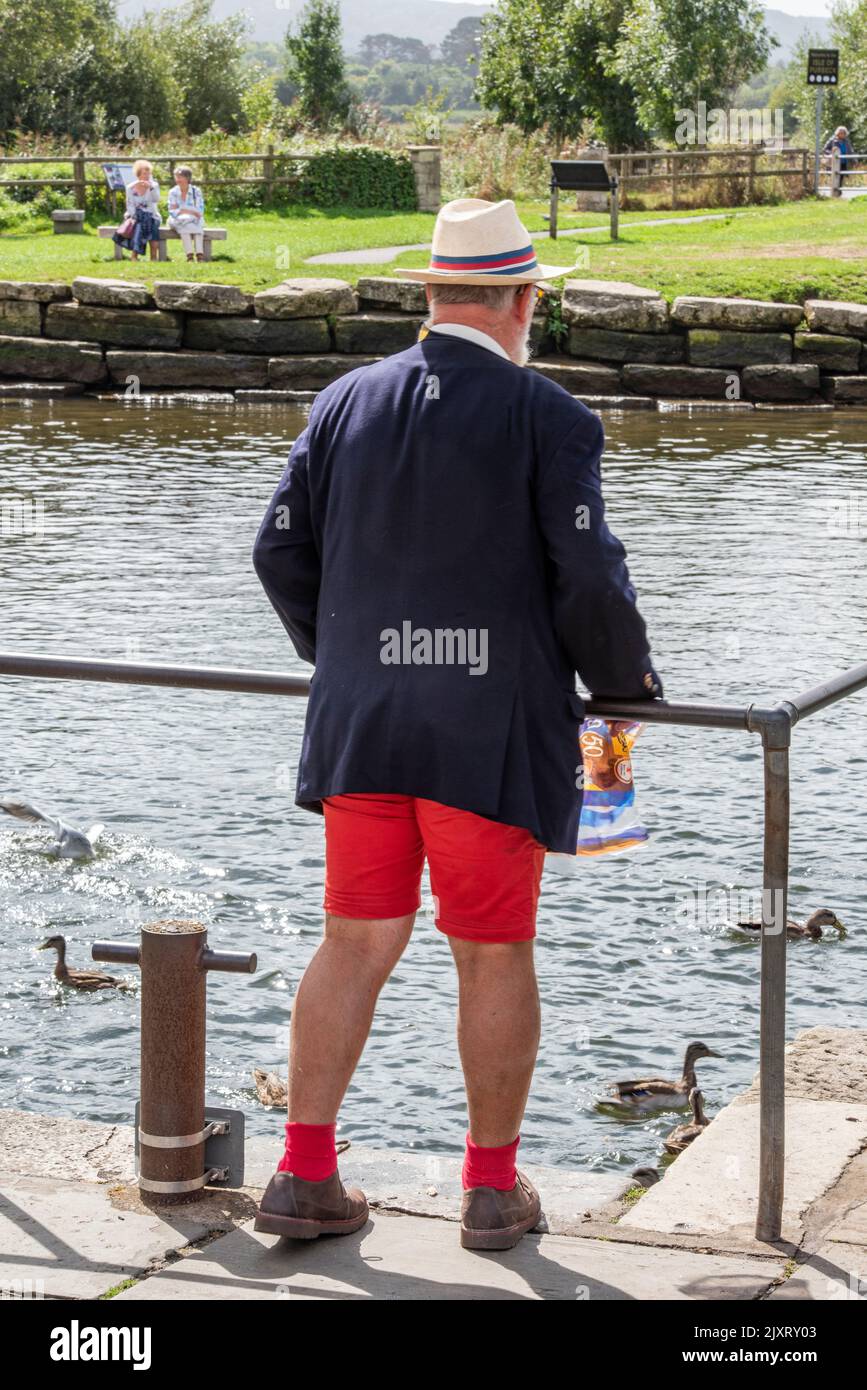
[609,0,774,140]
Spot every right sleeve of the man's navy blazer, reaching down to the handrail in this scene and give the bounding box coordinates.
[536,405,663,699]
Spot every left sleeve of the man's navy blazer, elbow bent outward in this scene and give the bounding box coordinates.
[253,430,322,664]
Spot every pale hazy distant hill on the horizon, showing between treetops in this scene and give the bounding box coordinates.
[118,0,828,63]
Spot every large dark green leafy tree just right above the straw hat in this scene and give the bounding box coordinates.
[475,0,645,150]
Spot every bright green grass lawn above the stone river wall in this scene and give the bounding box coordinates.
[0,197,867,303]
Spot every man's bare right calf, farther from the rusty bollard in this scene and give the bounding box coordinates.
[449,937,540,1148]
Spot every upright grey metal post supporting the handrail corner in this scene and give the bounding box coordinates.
[752,705,795,1241]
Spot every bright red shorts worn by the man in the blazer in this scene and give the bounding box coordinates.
[322,794,545,941]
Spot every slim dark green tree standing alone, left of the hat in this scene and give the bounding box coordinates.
[286,0,349,129]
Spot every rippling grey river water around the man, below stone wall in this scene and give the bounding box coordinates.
[0,400,867,1170]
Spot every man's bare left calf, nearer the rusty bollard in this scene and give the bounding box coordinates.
[289,913,414,1138]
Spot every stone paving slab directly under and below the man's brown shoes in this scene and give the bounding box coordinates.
[117,1212,784,1302]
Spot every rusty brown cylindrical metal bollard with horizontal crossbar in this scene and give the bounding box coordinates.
[92,919,256,1205]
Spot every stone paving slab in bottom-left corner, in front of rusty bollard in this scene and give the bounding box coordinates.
[0,1165,219,1298]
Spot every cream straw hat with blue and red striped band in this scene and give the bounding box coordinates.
[400,197,570,285]
